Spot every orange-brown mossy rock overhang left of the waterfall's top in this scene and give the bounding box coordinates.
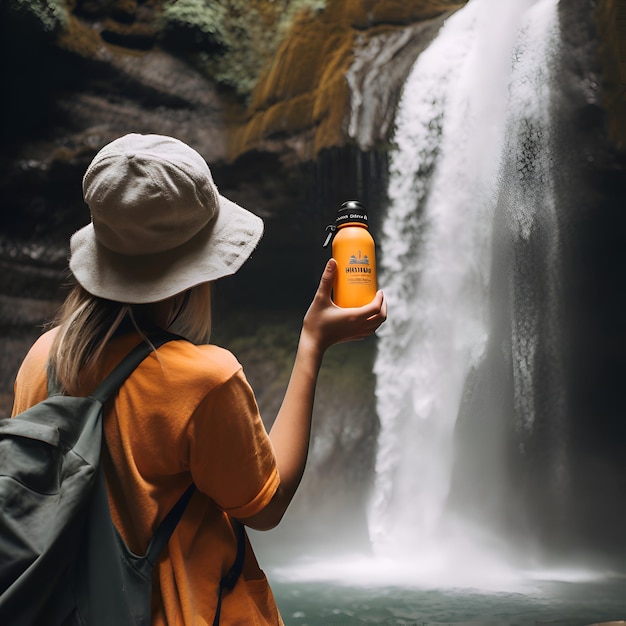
[229,0,466,159]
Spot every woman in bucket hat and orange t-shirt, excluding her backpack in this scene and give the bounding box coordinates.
[14,134,386,625]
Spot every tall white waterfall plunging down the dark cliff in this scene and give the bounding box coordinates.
[369,0,563,575]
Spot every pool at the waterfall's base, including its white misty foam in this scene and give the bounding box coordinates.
[267,562,626,626]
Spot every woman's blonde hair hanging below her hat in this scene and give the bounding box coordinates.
[50,283,211,395]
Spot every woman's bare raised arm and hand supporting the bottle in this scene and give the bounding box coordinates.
[241,259,387,530]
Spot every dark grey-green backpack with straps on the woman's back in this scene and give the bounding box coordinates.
[0,333,245,626]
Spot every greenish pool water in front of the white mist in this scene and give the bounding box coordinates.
[272,581,626,626]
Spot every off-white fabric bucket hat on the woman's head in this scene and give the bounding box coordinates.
[70,133,263,304]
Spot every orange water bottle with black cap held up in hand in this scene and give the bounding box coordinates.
[324,200,377,307]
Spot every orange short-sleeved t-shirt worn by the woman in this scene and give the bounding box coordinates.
[13,330,282,626]
